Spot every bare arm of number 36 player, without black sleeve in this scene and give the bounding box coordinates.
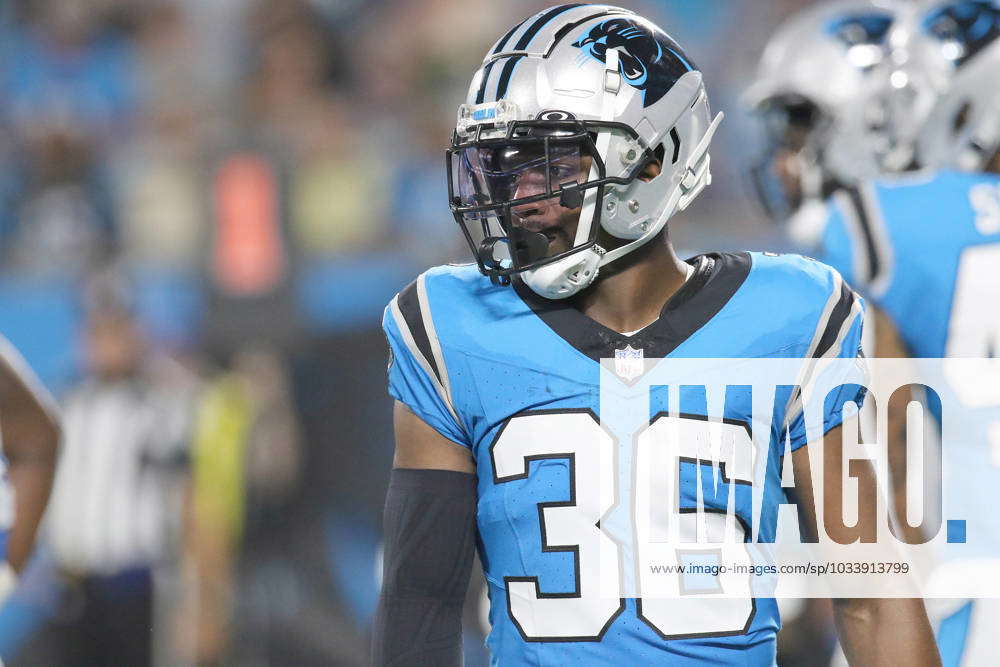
[792,428,941,667]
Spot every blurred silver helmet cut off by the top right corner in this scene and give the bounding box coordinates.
[895,0,1000,171]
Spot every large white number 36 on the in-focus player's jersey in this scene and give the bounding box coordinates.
[490,411,754,641]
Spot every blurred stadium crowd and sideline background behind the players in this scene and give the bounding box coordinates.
[0,0,844,665]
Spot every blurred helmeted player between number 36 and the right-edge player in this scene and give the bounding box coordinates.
[744,0,937,552]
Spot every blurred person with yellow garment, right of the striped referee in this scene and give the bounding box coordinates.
[178,346,363,665]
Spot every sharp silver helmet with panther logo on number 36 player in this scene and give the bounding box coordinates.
[448,5,722,299]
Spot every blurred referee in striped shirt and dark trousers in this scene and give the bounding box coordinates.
[15,274,196,667]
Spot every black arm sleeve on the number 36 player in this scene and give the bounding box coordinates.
[372,469,476,667]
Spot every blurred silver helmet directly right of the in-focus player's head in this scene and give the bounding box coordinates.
[745,0,896,220]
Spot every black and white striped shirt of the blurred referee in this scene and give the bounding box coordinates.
[46,362,196,574]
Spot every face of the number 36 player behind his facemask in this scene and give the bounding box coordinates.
[511,151,592,257]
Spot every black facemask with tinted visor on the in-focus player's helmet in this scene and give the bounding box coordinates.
[446,120,656,282]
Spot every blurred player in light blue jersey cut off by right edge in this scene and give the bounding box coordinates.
[819,0,1000,665]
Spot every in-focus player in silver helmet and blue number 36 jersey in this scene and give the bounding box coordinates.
[373,4,937,666]
